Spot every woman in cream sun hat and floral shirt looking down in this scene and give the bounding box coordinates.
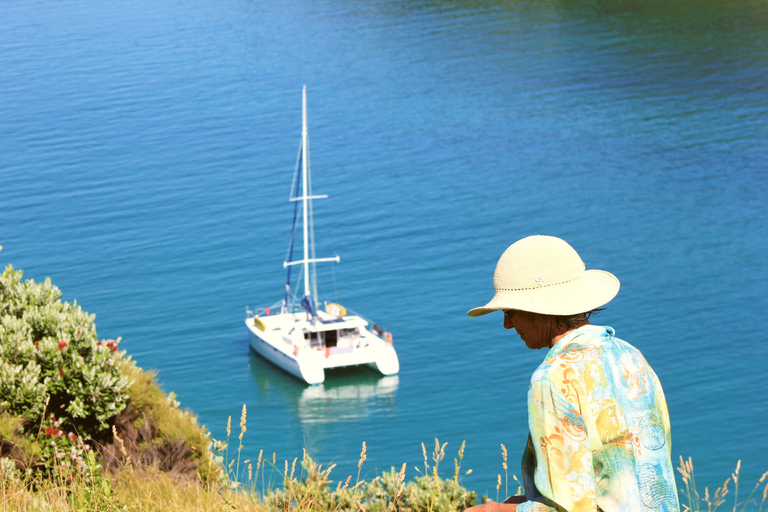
[467,235,680,512]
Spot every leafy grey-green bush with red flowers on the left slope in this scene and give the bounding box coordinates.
[0,265,131,474]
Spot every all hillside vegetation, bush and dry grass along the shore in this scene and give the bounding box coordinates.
[0,266,768,512]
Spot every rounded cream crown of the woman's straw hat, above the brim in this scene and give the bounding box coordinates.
[493,235,586,291]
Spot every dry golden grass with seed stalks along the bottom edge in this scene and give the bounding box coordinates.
[0,407,768,512]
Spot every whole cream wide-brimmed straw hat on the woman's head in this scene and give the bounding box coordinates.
[468,235,619,316]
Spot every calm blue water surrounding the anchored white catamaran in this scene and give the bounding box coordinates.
[0,0,768,497]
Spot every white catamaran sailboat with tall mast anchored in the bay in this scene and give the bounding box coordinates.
[245,86,400,384]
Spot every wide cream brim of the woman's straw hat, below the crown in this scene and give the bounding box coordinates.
[467,270,620,316]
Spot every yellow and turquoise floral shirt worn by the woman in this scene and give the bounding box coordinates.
[517,325,680,512]
